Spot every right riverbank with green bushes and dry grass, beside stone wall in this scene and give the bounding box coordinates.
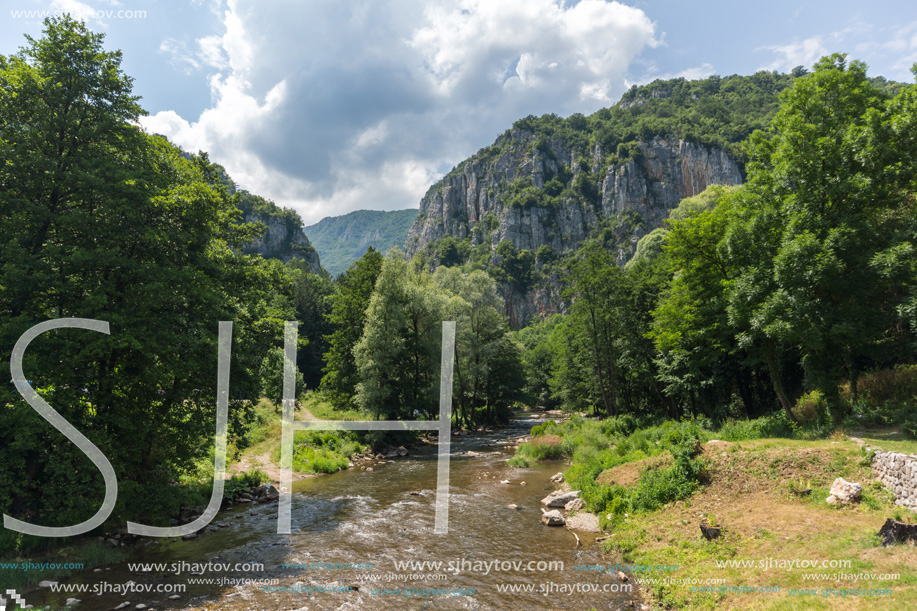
[509,414,917,610]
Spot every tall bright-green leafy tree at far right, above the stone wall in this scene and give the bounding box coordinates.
[729,54,917,419]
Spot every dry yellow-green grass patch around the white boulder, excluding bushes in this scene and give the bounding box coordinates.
[605,439,917,610]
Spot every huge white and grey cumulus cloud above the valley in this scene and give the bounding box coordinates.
[142,0,658,223]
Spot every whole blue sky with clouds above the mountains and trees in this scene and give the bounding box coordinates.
[0,0,917,225]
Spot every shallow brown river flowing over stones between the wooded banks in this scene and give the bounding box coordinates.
[28,415,639,611]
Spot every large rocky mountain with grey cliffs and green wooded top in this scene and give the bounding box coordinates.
[405,72,804,327]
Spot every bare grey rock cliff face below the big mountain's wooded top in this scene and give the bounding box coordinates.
[405,128,742,328]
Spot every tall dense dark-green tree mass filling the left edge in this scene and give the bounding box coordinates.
[0,16,292,540]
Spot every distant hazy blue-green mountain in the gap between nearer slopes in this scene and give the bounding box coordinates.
[304,208,417,276]
